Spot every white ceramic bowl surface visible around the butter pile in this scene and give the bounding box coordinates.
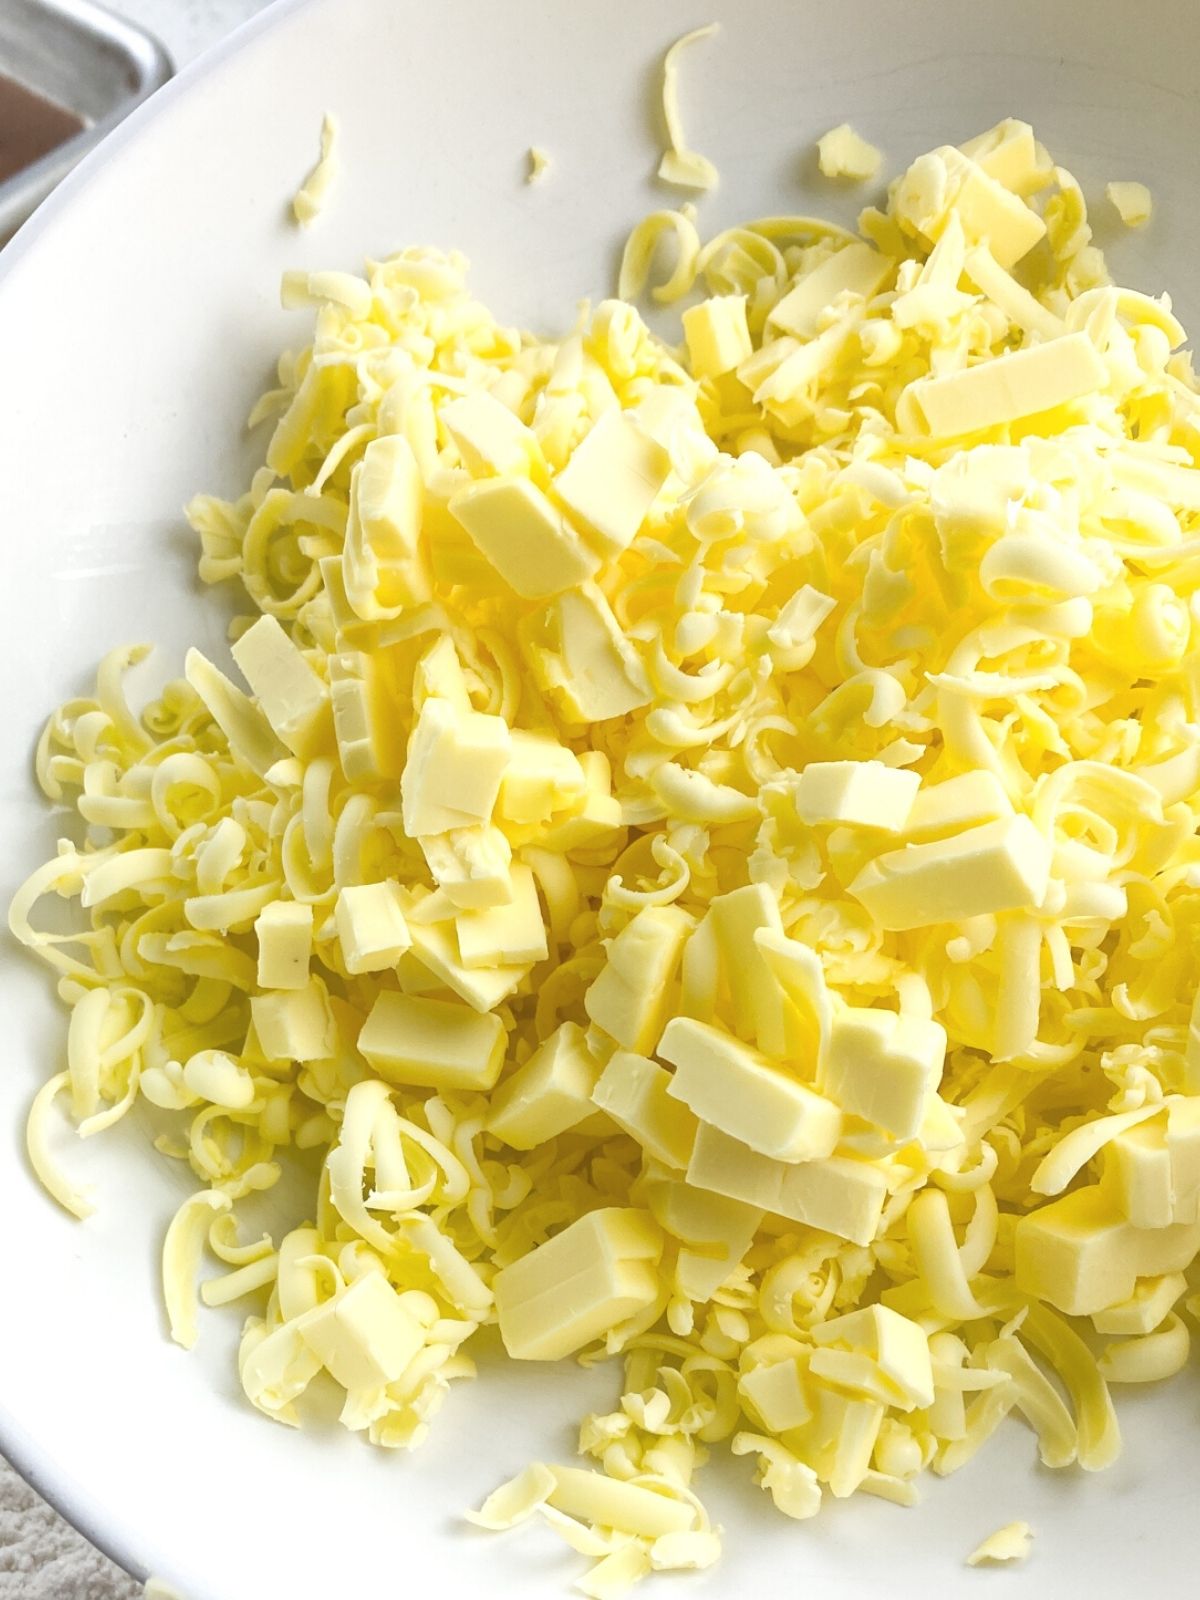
[0,0,1200,1600]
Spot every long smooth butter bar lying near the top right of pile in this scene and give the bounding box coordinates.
[907,333,1109,438]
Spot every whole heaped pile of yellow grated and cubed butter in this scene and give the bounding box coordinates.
[11,122,1200,1597]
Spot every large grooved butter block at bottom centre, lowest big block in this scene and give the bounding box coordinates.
[491,1206,662,1362]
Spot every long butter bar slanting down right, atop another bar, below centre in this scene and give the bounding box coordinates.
[658,1016,842,1162]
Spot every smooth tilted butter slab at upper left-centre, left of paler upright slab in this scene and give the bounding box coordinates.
[450,478,600,600]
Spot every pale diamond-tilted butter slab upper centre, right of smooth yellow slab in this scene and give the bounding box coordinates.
[556,411,670,556]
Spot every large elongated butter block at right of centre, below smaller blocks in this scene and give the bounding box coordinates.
[850,816,1051,933]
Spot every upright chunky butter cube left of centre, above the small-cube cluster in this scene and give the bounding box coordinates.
[400,699,510,838]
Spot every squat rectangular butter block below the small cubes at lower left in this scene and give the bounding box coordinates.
[358,990,507,1090]
